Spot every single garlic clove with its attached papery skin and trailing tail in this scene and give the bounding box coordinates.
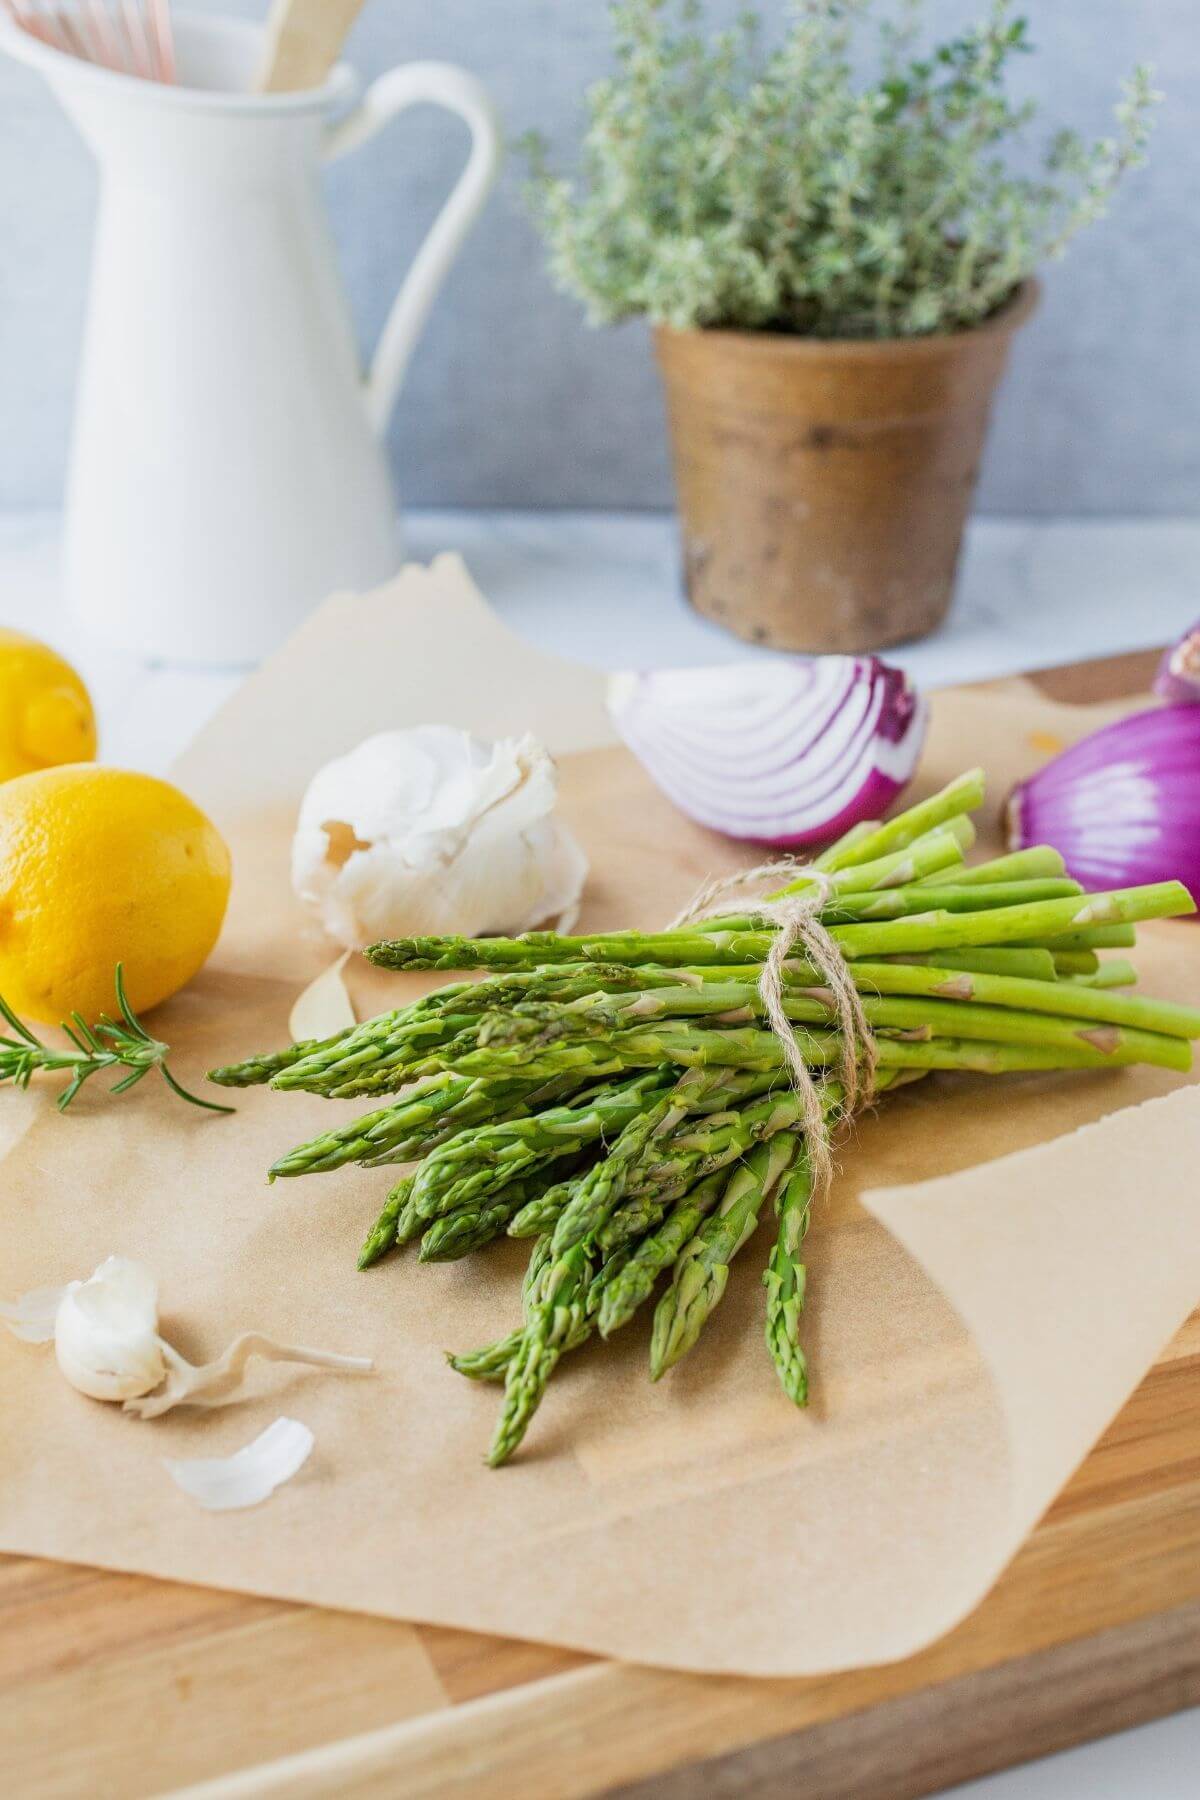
[4,1256,372,1418]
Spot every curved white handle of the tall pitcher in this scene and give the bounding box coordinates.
[324,63,502,434]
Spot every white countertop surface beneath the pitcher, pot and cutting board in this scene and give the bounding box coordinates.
[0,513,1200,1800]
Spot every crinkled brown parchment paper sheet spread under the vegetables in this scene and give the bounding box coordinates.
[0,560,1200,1676]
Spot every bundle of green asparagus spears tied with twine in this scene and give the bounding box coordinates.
[212,770,1200,1465]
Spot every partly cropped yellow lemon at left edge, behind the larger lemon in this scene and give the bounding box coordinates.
[0,628,95,781]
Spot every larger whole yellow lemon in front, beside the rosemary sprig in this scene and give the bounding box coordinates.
[0,763,230,1022]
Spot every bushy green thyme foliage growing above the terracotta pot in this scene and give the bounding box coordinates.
[525,0,1160,338]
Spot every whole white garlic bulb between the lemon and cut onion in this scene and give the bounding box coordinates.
[291,725,587,949]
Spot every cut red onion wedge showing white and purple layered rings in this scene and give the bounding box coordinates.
[608,657,927,848]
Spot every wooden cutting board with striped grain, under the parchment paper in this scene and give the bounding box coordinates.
[0,657,1200,1800]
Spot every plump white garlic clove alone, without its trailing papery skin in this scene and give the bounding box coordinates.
[54,1256,166,1400]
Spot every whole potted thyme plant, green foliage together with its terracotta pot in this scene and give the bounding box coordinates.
[531,0,1157,650]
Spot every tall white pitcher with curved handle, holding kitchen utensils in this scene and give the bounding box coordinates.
[0,14,500,662]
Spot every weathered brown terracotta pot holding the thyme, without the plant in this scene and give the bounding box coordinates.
[655,281,1038,650]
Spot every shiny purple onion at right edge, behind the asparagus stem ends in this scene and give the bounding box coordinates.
[1007,706,1200,895]
